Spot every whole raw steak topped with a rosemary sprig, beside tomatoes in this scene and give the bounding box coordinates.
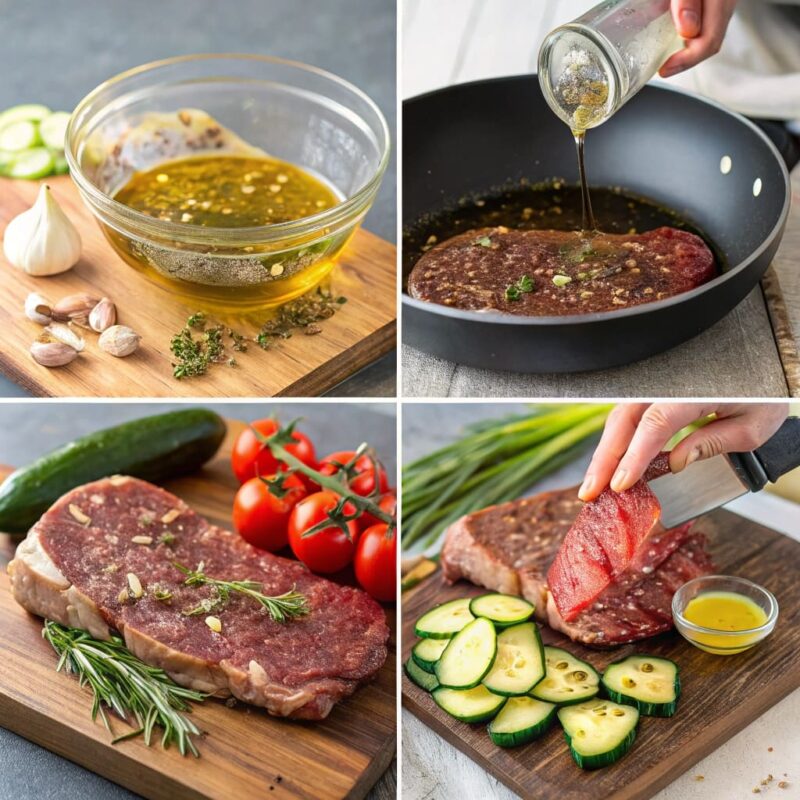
[9,477,389,719]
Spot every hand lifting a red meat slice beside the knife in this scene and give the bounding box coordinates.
[578,403,789,501]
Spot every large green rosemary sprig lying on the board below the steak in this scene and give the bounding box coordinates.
[42,620,206,757]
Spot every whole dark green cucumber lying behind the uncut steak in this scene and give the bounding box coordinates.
[0,408,226,534]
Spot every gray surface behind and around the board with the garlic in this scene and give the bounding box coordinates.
[0,0,397,397]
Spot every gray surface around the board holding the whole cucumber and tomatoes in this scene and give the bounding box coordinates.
[0,402,397,800]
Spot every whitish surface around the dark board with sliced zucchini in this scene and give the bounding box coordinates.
[401,403,800,800]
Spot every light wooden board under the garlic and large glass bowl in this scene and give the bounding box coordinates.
[0,176,397,397]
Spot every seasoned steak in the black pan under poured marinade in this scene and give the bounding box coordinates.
[408,227,716,316]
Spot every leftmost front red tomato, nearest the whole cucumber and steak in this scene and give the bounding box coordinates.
[233,475,306,553]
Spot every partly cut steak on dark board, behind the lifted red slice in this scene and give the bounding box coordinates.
[441,476,713,647]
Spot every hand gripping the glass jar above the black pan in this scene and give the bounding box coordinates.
[658,0,736,78]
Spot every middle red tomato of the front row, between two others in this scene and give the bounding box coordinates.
[289,491,358,573]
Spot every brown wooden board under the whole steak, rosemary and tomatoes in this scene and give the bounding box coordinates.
[0,423,396,800]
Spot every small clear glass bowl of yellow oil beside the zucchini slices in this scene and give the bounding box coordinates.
[672,575,778,656]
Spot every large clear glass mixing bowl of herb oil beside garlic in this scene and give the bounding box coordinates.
[66,55,389,311]
